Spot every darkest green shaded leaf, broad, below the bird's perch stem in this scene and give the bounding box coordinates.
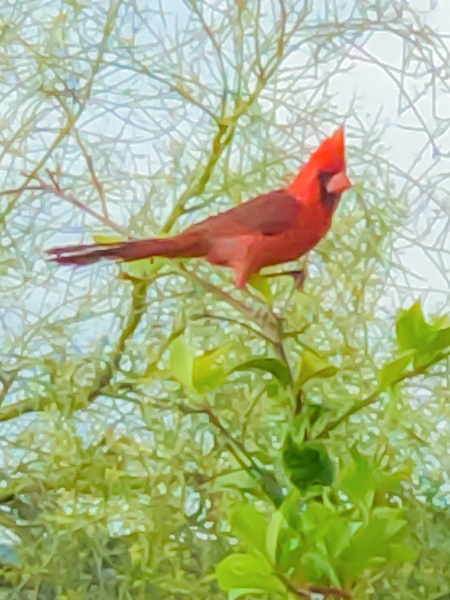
[283,435,334,491]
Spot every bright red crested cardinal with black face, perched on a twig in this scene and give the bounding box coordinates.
[48,126,351,288]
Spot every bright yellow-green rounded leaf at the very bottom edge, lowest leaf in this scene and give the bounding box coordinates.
[216,553,286,594]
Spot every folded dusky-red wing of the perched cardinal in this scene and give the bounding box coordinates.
[208,190,302,235]
